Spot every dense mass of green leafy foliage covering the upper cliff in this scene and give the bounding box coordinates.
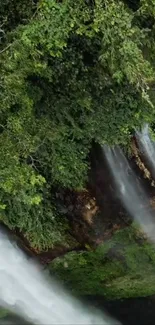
[0,0,155,247]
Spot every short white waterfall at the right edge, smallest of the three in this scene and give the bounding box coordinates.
[136,124,155,175]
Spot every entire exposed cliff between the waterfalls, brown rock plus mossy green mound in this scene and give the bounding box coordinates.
[3,140,155,300]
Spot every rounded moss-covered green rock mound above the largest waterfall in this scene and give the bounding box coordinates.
[49,226,155,299]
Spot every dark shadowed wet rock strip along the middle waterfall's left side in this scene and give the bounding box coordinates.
[89,145,132,234]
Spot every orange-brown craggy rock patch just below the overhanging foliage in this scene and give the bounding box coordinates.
[56,186,99,245]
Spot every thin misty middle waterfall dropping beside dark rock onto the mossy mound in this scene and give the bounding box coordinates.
[103,145,155,242]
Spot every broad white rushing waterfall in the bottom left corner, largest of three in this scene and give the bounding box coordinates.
[0,232,120,325]
